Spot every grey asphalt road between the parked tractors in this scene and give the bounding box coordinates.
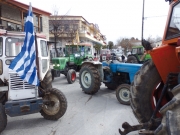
[1,75,138,135]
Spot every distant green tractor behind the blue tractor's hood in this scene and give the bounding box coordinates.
[126,46,151,64]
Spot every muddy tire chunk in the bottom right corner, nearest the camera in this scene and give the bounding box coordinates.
[155,84,180,135]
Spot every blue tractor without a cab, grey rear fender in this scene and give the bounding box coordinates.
[79,60,142,105]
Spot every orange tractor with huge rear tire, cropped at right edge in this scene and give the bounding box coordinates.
[119,0,180,135]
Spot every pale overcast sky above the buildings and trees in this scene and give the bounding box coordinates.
[17,0,169,44]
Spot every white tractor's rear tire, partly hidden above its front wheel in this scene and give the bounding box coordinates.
[40,70,52,90]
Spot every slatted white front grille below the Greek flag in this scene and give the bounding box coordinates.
[9,73,35,90]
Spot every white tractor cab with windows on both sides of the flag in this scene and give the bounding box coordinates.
[0,29,49,85]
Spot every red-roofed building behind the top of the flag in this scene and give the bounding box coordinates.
[0,0,51,39]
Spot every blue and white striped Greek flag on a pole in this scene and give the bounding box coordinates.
[9,3,39,86]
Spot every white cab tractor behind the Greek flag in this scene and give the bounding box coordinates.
[0,29,67,133]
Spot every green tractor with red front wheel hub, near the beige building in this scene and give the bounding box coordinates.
[51,43,94,84]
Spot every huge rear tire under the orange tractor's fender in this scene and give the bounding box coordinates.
[130,60,161,123]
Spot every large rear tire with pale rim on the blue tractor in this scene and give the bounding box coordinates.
[79,64,101,94]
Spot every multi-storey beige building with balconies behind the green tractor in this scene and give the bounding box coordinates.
[49,16,106,47]
